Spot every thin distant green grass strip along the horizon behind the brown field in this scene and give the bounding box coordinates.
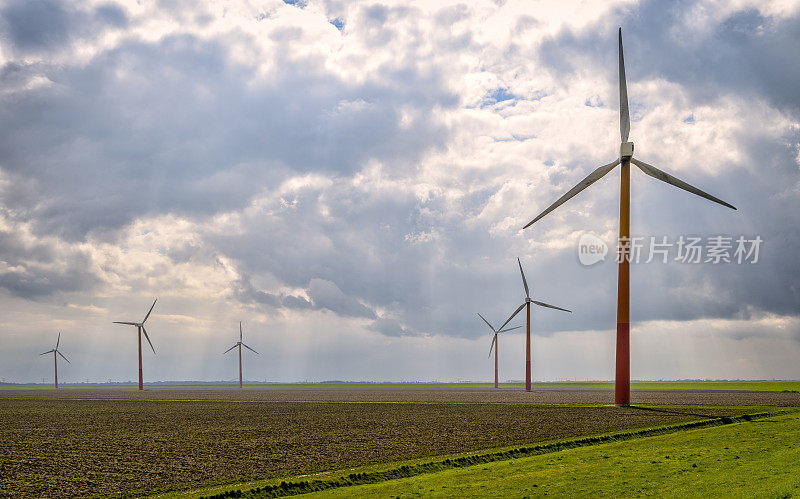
[6,381,800,392]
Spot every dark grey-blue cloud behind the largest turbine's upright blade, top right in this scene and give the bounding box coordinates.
[538,0,800,116]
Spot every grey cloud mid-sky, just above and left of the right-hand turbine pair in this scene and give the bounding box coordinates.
[206,172,544,337]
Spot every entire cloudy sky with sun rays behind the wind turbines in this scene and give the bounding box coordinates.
[0,0,800,382]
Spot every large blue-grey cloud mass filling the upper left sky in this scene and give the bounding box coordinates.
[0,28,454,239]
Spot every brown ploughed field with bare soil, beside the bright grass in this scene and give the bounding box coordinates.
[0,390,780,496]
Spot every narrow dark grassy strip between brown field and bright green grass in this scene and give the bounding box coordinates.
[201,411,785,499]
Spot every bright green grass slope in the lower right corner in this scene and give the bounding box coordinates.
[300,413,800,497]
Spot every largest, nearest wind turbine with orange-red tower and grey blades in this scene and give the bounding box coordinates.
[523,28,736,405]
